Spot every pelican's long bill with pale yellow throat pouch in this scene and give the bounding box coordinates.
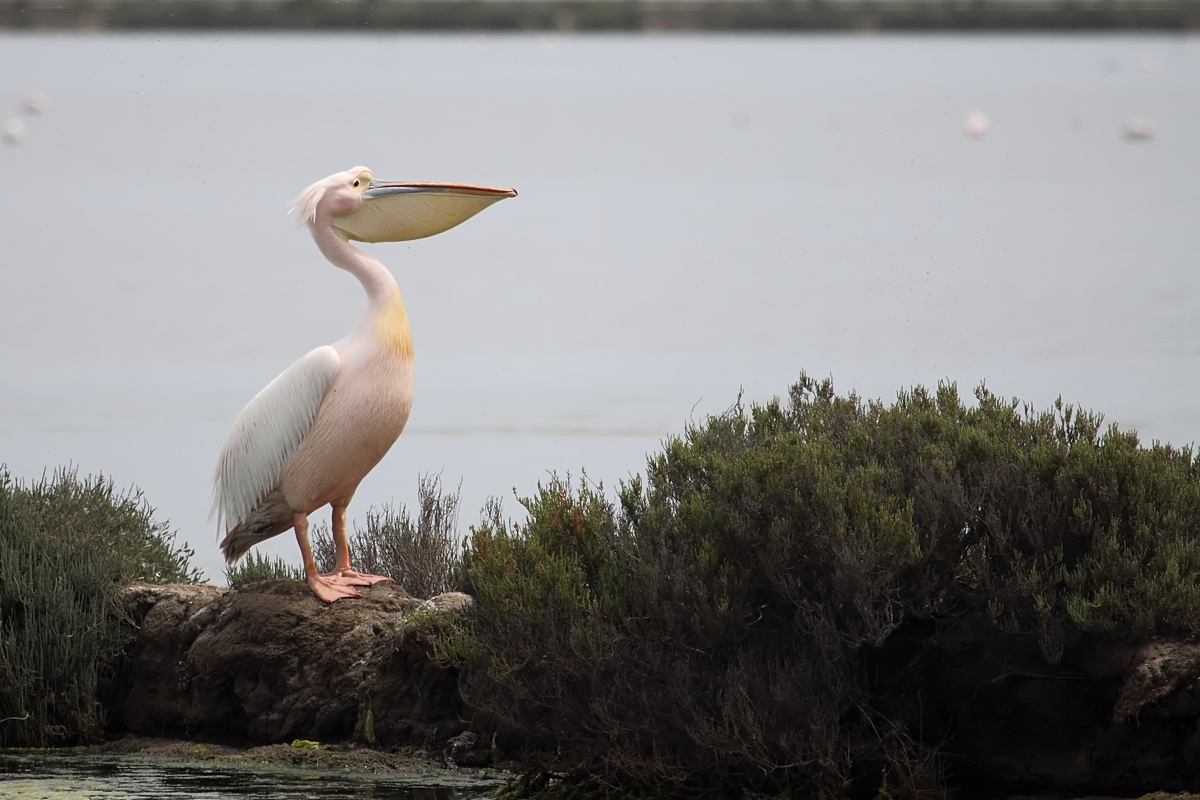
[332,181,516,242]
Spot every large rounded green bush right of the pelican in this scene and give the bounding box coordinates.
[439,375,1200,796]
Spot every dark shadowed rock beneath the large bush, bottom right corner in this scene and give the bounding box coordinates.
[871,625,1200,795]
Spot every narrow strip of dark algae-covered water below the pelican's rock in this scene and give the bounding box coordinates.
[0,753,496,800]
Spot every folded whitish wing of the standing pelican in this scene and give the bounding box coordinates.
[212,345,342,533]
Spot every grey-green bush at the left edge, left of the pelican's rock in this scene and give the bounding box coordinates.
[0,465,199,747]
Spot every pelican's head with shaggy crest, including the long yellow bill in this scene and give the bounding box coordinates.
[293,167,517,242]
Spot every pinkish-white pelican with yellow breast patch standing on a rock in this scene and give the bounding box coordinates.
[214,167,516,603]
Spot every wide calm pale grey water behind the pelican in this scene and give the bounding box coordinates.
[0,34,1200,578]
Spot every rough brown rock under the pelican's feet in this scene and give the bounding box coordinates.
[108,581,470,748]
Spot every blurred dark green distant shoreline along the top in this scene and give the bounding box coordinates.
[7,0,1200,32]
